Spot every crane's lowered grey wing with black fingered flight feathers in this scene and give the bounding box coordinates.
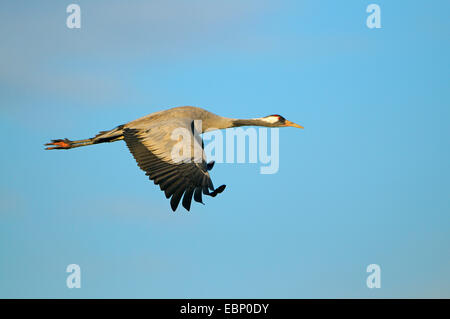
[123,119,225,211]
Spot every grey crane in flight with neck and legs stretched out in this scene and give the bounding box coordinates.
[45,106,303,211]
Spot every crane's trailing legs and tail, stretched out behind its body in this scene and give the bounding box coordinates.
[45,125,123,150]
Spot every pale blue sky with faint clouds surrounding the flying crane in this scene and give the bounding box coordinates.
[0,0,450,298]
